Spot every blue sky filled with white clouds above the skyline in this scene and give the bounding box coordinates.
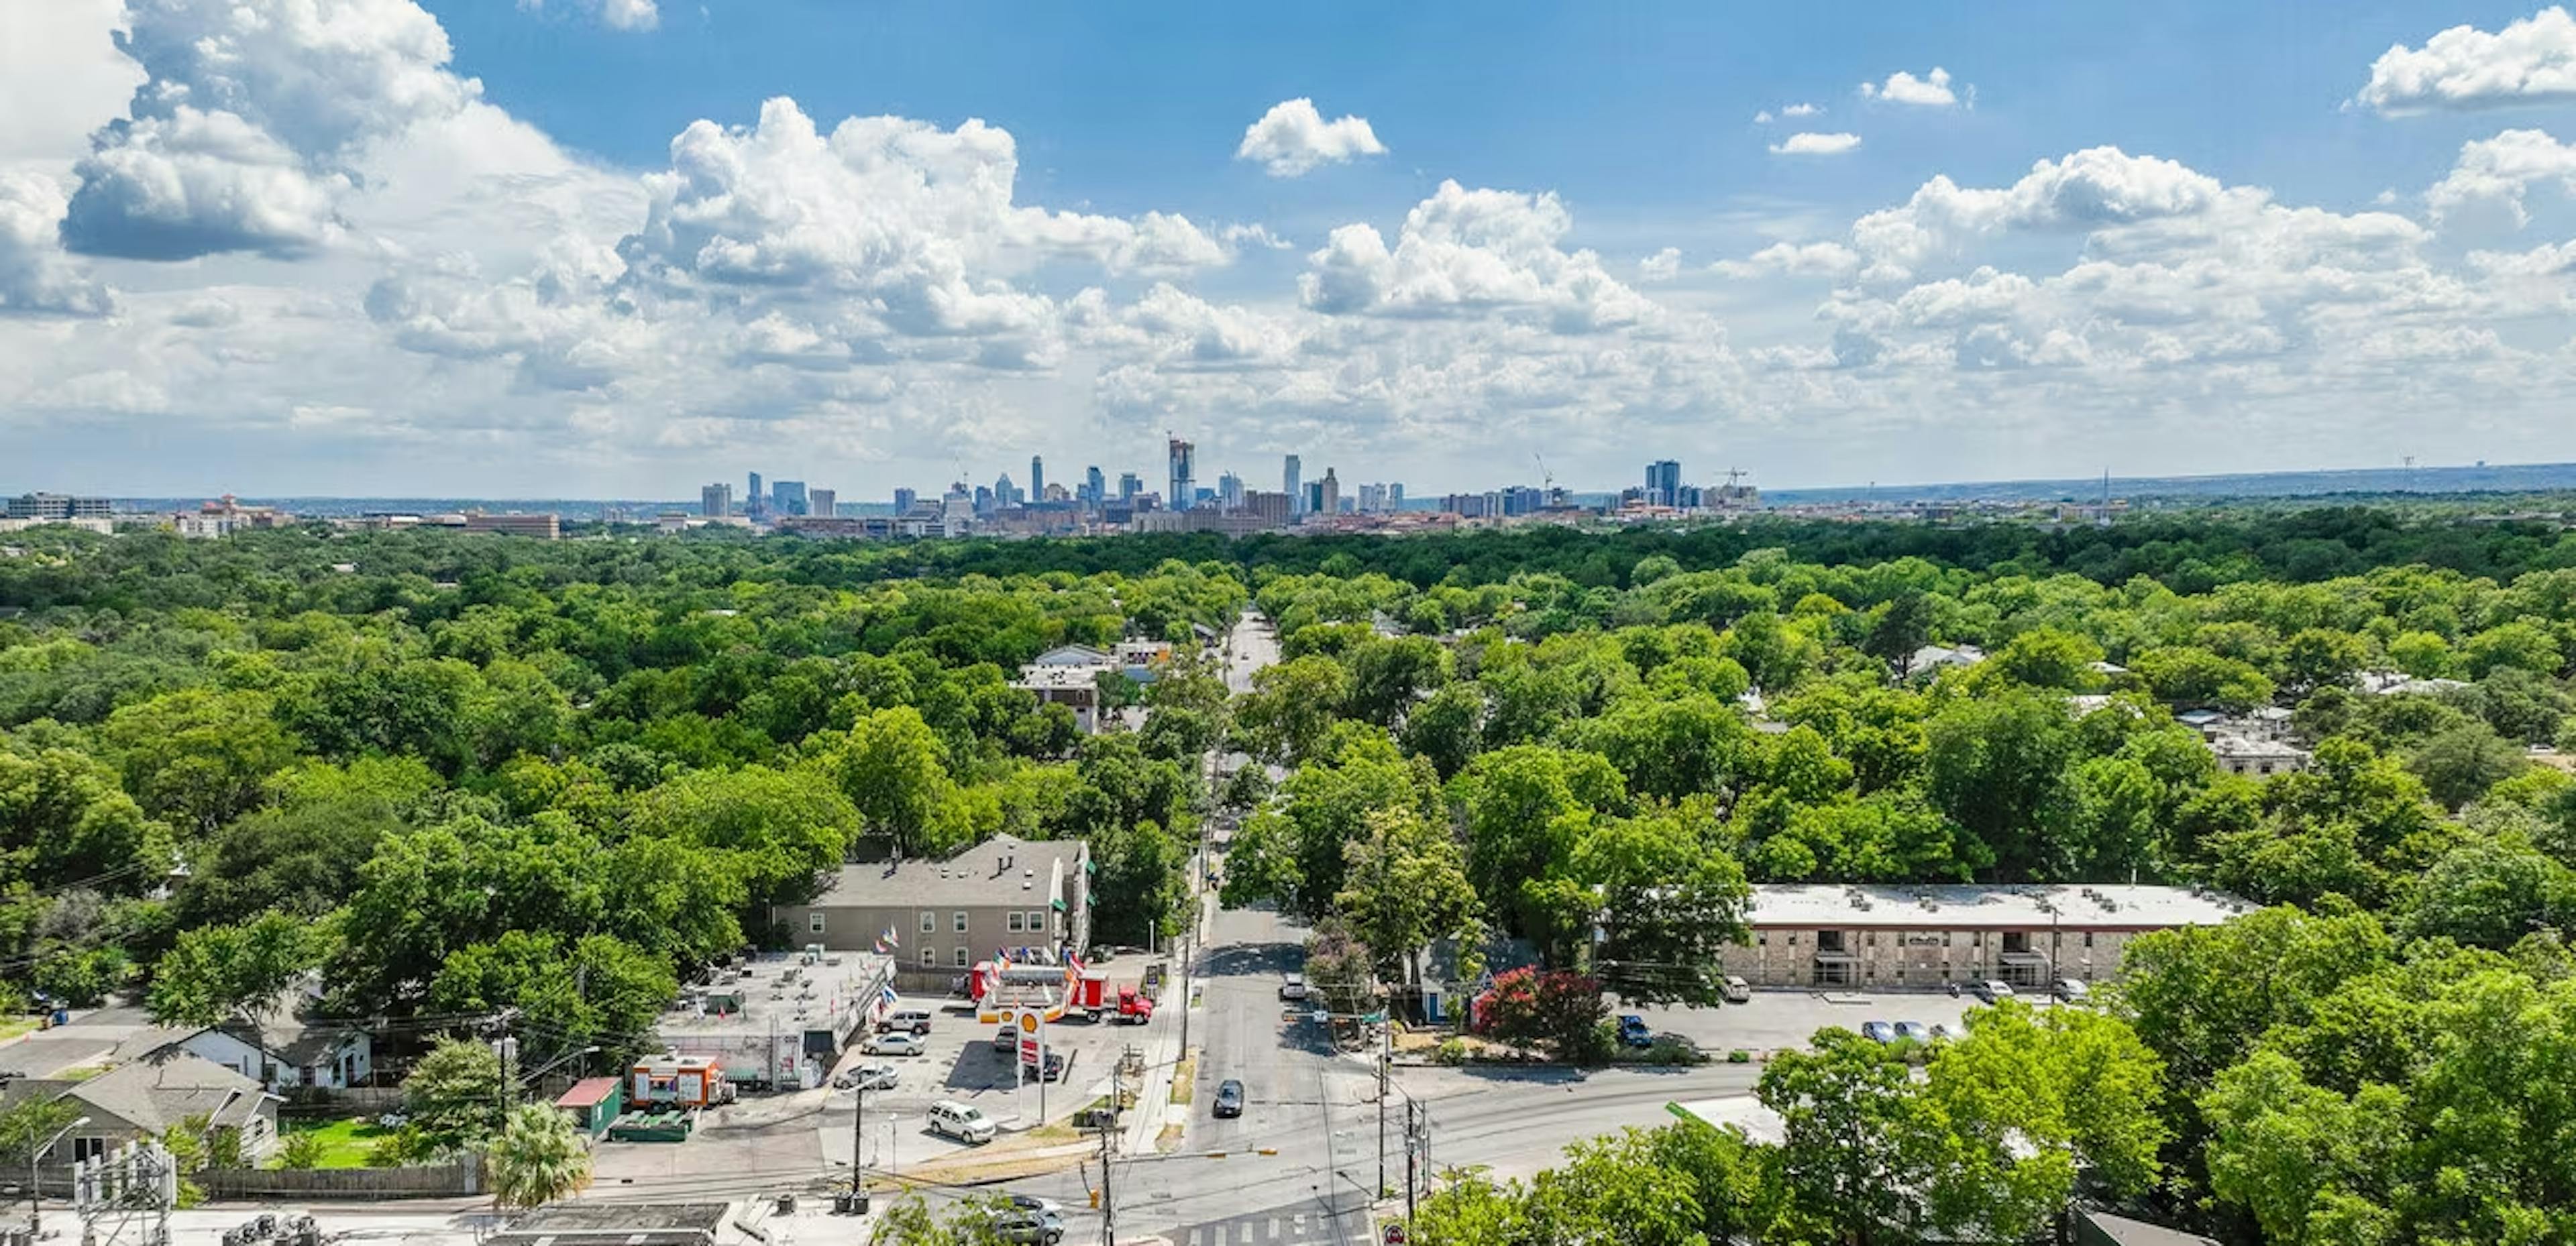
[0,0,2576,497]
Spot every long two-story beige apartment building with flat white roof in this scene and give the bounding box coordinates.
[1721,883,2254,991]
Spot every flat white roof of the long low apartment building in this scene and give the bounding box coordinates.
[1747,883,2254,929]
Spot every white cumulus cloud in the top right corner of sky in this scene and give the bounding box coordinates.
[2355,5,2576,116]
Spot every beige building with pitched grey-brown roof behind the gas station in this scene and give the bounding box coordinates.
[770,834,1092,994]
